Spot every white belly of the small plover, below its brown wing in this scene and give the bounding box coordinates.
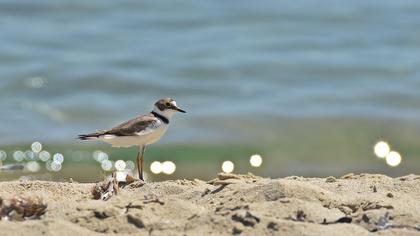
[100,126,167,147]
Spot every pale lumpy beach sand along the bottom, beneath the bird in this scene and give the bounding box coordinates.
[0,174,420,236]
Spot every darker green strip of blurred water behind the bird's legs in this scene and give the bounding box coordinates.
[0,144,263,182]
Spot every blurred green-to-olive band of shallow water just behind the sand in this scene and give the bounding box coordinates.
[0,117,420,179]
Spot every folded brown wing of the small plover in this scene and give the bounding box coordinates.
[79,114,159,140]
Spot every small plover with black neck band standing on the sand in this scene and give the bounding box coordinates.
[79,98,186,181]
